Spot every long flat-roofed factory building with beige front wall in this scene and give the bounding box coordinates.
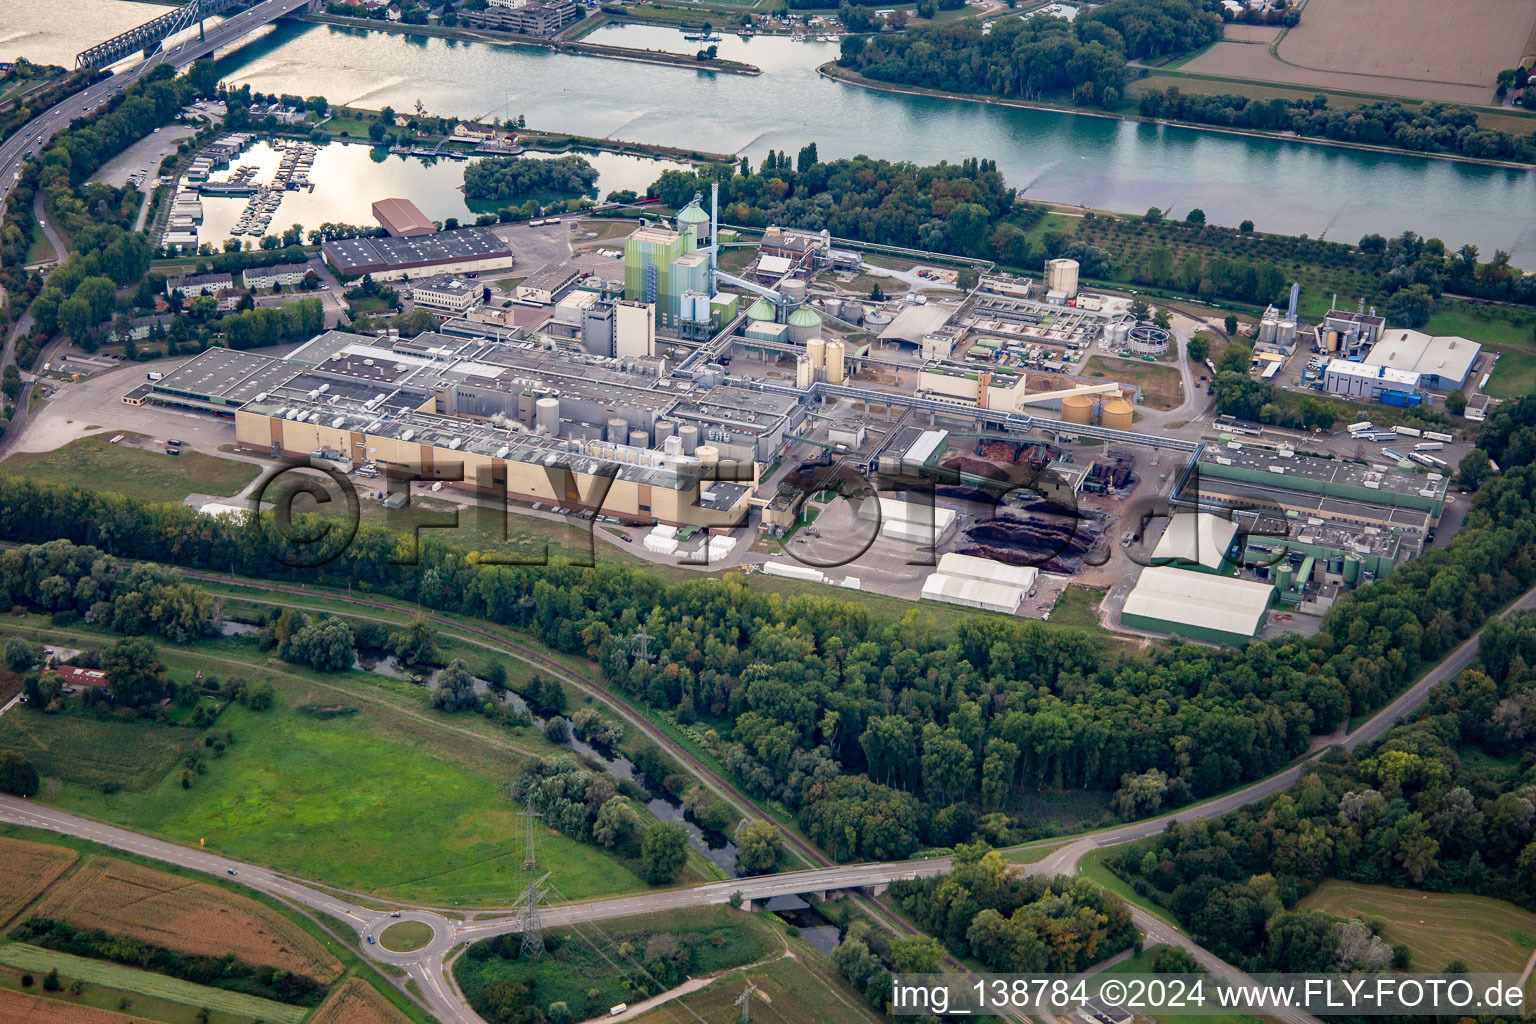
[123,330,768,528]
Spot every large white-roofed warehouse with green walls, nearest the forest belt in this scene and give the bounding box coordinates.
[1120,565,1275,643]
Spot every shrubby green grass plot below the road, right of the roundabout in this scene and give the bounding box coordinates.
[453,906,782,1021]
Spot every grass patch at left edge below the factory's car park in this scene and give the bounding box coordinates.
[0,434,257,502]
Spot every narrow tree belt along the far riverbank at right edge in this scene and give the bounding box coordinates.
[1140,86,1536,163]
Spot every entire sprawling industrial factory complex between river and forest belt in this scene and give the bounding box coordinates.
[123,184,1478,643]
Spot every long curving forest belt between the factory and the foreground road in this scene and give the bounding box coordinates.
[0,398,1536,860]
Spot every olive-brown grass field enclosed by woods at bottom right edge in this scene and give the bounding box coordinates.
[1298,880,1536,973]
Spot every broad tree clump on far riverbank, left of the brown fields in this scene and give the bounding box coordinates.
[837,0,1221,109]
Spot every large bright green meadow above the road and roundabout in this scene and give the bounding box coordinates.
[0,626,678,906]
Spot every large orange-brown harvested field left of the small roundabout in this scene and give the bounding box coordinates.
[37,858,341,984]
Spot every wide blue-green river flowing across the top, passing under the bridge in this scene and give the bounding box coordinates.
[0,0,1536,269]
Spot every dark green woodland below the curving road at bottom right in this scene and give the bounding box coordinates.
[1111,613,1536,972]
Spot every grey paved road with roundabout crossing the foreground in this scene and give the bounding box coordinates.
[0,588,1536,1024]
